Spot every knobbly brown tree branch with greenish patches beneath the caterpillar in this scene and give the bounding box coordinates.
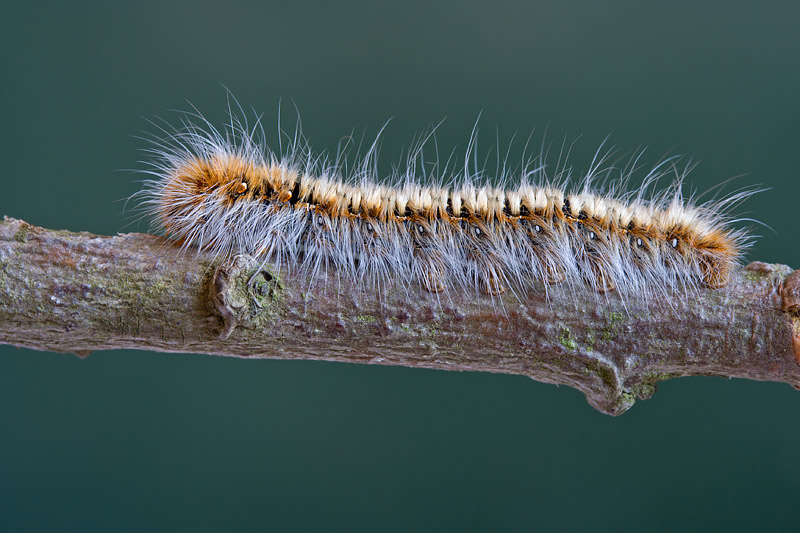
[0,214,800,415]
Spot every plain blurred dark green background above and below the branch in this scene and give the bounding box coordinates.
[0,1,800,531]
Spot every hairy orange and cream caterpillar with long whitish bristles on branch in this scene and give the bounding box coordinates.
[138,104,754,298]
